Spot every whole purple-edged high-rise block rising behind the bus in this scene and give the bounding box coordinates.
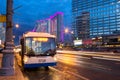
[34,12,64,43]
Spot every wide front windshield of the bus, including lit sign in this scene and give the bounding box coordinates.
[25,37,56,56]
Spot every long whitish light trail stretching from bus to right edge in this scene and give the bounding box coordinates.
[57,50,120,61]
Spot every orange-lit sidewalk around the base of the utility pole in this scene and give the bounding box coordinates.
[0,53,25,80]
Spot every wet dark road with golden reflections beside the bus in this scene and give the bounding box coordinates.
[23,51,120,80]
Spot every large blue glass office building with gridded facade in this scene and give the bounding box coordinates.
[72,0,120,39]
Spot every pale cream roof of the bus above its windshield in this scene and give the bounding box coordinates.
[24,32,55,38]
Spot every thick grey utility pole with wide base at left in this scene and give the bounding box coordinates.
[0,0,14,76]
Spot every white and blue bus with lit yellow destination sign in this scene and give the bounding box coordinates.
[21,32,57,68]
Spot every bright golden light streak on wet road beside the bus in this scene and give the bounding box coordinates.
[57,54,111,71]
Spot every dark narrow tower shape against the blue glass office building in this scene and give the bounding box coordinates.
[76,12,89,39]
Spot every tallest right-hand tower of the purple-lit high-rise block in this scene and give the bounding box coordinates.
[50,12,64,43]
